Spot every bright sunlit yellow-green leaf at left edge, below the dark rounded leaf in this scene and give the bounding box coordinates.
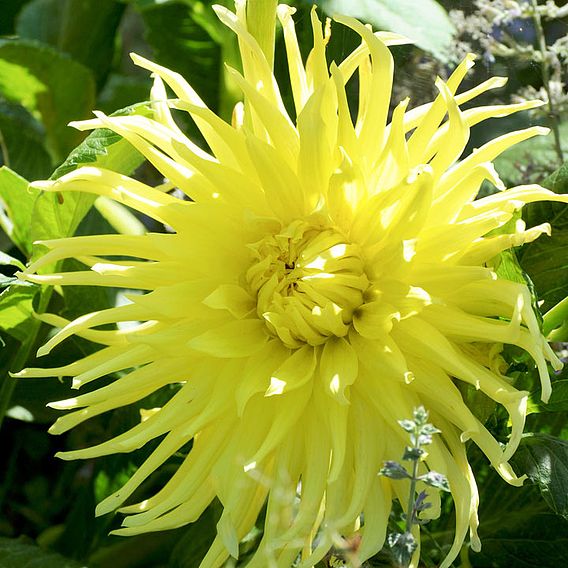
[0,166,39,254]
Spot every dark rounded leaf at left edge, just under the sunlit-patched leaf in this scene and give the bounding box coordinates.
[0,101,53,179]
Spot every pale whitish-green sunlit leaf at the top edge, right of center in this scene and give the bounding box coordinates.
[321,0,455,61]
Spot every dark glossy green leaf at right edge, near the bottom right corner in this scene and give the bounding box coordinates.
[512,433,568,520]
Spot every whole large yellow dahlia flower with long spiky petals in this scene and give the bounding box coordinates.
[16,0,564,568]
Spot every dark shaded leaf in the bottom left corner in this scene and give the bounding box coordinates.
[0,537,85,568]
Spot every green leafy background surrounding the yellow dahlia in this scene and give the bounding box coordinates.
[0,0,568,568]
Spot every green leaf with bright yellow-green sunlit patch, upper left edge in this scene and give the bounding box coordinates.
[0,40,95,162]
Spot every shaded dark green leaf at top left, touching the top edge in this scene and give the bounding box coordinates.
[16,0,124,86]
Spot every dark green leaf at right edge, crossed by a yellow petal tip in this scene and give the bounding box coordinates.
[518,160,568,311]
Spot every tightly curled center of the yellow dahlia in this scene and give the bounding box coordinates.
[247,220,369,349]
